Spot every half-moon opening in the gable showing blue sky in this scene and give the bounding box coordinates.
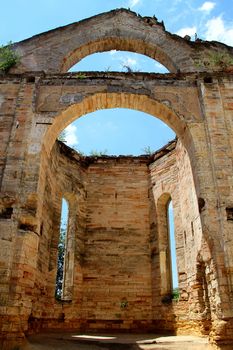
[69,50,169,73]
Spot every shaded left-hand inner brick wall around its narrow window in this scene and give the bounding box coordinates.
[29,144,86,332]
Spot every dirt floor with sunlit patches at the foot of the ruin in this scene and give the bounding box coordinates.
[23,332,220,350]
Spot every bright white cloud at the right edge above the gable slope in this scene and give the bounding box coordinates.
[205,16,233,46]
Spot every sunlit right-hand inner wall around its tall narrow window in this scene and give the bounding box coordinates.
[150,142,206,332]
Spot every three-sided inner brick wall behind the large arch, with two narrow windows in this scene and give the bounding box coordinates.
[22,136,205,332]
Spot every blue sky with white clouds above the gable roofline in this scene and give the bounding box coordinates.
[0,0,233,45]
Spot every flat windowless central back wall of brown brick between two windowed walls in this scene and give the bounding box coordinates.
[83,154,152,330]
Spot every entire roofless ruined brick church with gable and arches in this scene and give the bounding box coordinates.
[0,9,233,349]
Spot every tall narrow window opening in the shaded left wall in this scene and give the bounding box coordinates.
[55,198,69,300]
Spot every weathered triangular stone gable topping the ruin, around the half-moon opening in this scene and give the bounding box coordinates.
[12,9,232,73]
